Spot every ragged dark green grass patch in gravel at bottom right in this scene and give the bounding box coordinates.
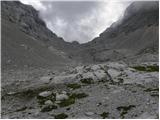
[117,105,136,119]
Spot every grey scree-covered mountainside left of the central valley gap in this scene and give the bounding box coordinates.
[1,1,77,69]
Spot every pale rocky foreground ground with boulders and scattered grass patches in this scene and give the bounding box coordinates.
[2,62,159,119]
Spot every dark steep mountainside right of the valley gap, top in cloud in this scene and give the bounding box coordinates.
[73,1,159,62]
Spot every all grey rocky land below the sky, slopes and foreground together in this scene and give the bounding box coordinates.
[1,1,159,119]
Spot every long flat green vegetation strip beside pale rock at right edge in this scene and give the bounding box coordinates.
[132,65,159,72]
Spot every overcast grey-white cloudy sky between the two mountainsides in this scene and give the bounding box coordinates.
[20,0,131,43]
